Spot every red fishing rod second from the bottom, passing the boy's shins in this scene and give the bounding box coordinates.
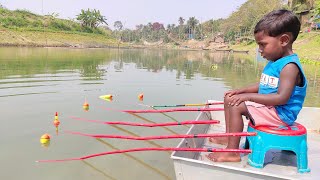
[65,131,257,140]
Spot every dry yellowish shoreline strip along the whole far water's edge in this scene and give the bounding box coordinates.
[0,28,320,62]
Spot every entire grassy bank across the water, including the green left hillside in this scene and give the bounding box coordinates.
[0,8,320,62]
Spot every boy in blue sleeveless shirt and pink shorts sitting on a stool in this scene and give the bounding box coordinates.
[207,10,307,162]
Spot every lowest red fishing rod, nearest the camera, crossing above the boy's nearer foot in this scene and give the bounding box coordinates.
[36,147,251,162]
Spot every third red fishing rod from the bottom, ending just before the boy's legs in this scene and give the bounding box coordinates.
[70,116,220,127]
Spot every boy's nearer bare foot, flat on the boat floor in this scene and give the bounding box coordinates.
[206,152,241,162]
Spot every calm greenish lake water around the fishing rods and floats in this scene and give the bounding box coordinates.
[0,48,320,180]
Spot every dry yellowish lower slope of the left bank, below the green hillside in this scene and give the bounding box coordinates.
[0,27,117,48]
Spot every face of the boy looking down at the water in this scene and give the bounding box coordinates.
[254,31,283,61]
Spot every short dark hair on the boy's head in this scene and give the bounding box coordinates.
[254,9,301,42]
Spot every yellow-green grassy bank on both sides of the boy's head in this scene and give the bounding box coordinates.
[232,31,320,65]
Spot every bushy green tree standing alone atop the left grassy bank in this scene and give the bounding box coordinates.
[77,9,108,28]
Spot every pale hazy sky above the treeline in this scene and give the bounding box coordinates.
[0,0,247,29]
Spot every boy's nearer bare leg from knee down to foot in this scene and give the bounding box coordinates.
[207,99,248,162]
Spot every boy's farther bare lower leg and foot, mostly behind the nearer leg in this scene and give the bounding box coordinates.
[209,97,230,145]
